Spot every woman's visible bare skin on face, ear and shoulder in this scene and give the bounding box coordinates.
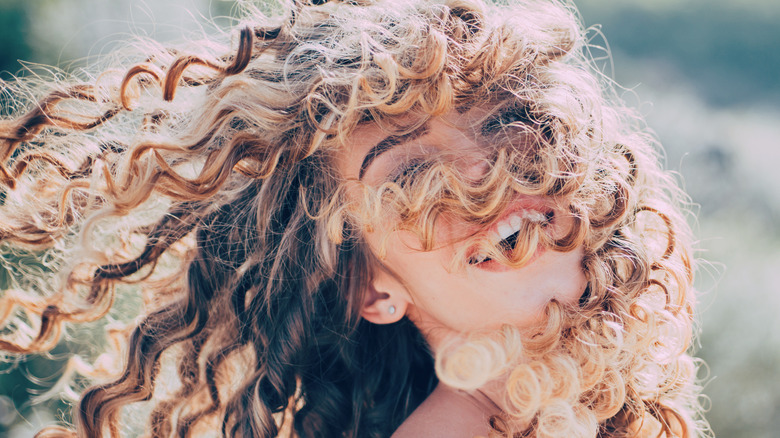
[338,110,586,437]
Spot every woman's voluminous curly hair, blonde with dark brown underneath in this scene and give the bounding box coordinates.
[0,0,706,437]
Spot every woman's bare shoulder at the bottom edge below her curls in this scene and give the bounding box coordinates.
[392,384,490,438]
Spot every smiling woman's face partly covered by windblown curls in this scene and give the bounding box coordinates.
[339,110,586,348]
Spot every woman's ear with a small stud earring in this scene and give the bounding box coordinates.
[360,269,409,324]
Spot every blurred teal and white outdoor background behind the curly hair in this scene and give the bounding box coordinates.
[0,0,780,438]
